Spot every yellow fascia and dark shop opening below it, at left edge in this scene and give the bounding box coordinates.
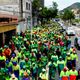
[0,25,16,46]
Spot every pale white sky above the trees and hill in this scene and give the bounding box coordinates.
[45,0,80,10]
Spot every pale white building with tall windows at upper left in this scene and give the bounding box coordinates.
[0,0,32,32]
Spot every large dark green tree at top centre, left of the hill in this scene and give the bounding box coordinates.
[39,2,58,22]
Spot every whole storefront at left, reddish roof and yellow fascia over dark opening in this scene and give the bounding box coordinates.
[0,14,18,47]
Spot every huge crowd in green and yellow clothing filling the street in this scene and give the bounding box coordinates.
[0,28,80,80]
